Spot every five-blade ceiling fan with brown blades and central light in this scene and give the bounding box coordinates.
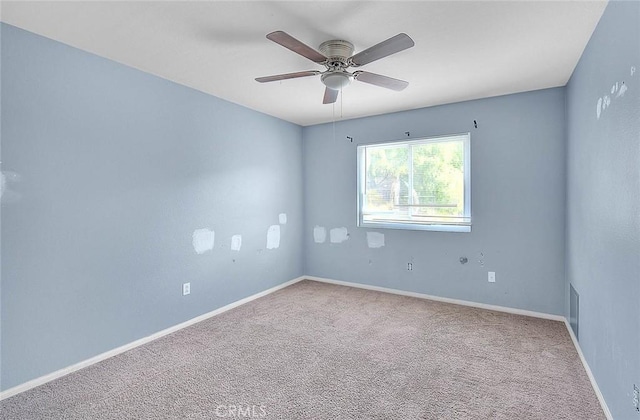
[256,31,415,104]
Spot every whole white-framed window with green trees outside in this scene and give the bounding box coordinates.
[358,133,471,232]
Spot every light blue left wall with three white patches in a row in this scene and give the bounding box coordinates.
[1,24,303,389]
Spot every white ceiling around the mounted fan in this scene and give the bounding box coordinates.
[0,0,607,125]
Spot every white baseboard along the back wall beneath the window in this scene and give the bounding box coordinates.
[305,276,565,321]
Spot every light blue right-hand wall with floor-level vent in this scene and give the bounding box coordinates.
[566,1,640,419]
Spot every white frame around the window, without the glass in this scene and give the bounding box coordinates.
[356,132,472,233]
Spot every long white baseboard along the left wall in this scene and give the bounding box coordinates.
[0,276,306,401]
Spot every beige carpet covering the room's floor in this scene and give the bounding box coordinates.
[0,281,604,420]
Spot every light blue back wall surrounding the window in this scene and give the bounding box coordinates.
[303,88,565,314]
